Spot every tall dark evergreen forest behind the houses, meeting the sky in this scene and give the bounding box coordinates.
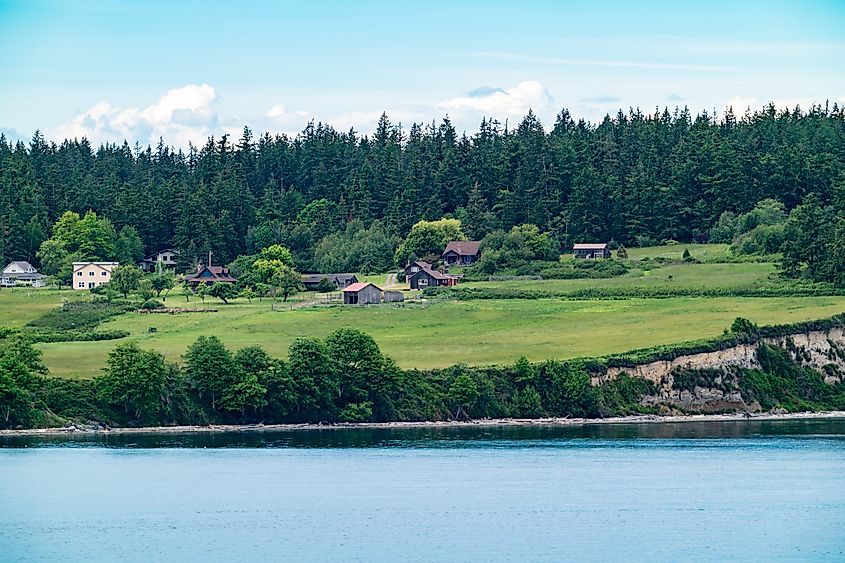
[0,105,845,271]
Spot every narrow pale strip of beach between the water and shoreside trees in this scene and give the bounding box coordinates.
[0,411,845,437]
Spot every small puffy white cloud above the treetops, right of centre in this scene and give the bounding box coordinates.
[437,80,554,117]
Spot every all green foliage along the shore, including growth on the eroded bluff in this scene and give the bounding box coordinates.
[8,316,845,432]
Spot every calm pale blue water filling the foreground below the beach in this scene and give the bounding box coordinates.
[0,421,845,561]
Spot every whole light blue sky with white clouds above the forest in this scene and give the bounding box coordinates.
[0,0,845,148]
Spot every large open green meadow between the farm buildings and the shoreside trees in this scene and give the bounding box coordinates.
[39,297,845,377]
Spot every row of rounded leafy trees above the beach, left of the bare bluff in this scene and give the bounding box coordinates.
[0,327,653,428]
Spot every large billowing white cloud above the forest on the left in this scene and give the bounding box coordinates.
[48,84,220,147]
